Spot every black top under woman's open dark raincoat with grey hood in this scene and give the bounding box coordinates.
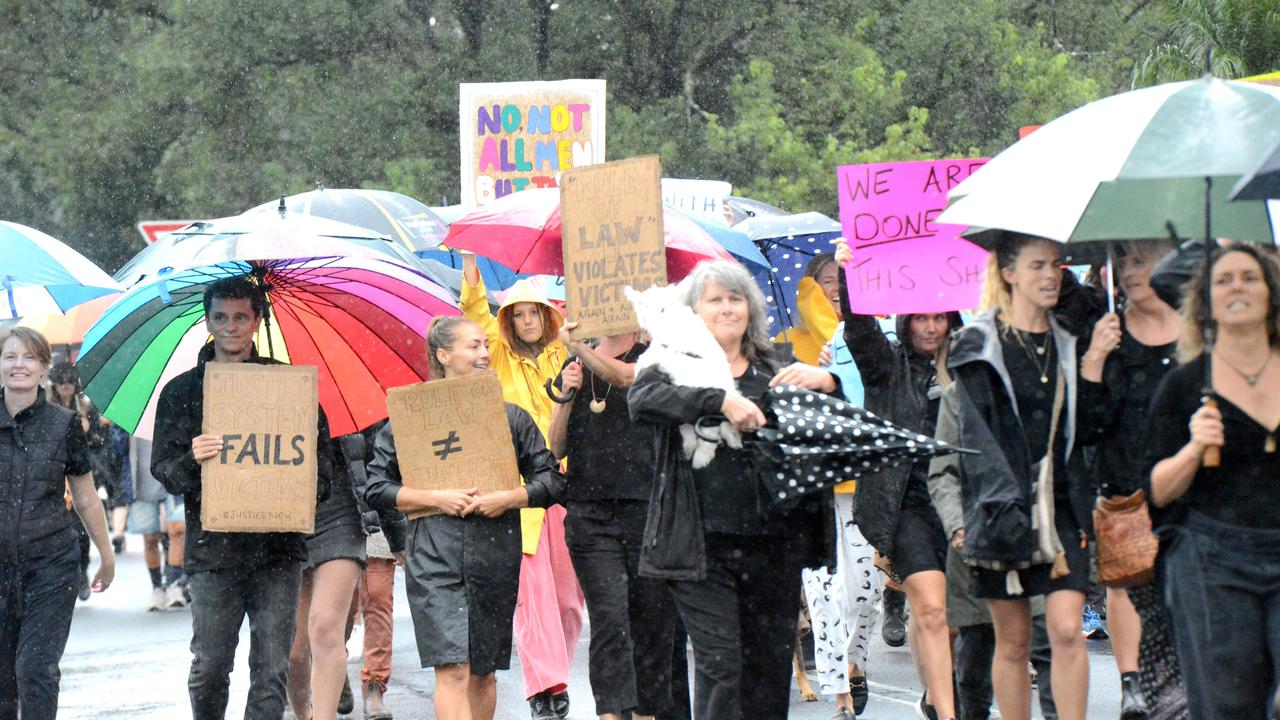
[1000,328,1068,491]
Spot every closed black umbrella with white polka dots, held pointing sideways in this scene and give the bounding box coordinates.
[755,386,974,502]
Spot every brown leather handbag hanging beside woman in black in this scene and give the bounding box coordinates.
[1093,489,1160,588]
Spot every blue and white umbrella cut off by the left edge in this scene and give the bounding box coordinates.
[0,220,124,319]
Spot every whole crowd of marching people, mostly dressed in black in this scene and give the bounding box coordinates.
[0,228,1280,720]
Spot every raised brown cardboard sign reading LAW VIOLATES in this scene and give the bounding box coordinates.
[561,155,667,338]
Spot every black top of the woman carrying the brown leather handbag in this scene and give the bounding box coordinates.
[1094,332,1178,496]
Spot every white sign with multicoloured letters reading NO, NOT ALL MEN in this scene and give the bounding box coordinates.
[458,79,604,208]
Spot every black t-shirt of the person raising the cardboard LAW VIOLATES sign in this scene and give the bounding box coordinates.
[564,343,653,502]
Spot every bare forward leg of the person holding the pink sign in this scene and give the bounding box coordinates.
[904,570,956,717]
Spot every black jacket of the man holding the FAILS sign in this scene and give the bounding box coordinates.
[151,343,334,573]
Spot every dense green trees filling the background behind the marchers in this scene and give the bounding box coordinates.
[0,0,1167,269]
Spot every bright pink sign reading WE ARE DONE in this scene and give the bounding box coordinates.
[836,158,987,315]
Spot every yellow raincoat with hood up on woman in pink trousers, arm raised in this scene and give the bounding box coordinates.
[460,271,567,555]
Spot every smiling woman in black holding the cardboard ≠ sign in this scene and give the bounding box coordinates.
[365,318,564,720]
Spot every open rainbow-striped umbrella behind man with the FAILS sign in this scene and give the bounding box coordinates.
[79,256,460,438]
